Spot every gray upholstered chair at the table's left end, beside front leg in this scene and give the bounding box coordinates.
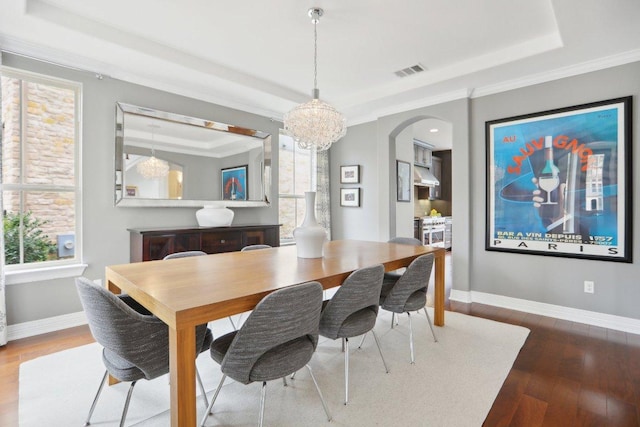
[76,277,213,427]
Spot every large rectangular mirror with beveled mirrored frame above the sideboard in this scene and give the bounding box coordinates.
[115,103,271,207]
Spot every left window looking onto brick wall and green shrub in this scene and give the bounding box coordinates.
[0,68,82,274]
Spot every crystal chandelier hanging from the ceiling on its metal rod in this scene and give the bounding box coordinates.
[284,8,347,151]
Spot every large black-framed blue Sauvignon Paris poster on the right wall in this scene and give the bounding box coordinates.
[485,96,633,262]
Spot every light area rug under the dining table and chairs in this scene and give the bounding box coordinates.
[19,308,529,427]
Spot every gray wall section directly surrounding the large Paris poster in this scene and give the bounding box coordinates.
[470,63,640,319]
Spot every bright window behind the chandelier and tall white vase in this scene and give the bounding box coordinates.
[278,133,316,244]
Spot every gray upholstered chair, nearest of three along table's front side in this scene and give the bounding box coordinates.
[201,282,331,426]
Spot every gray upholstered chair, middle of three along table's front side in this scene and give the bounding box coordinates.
[320,264,389,405]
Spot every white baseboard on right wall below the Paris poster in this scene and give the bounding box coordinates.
[449,289,640,334]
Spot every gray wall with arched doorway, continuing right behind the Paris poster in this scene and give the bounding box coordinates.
[331,63,640,319]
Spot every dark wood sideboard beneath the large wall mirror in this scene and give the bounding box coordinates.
[128,224,280,262]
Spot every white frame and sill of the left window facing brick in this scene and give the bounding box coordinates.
[0,66,87,285]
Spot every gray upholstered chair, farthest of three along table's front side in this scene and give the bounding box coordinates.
[380,254,438,364]
